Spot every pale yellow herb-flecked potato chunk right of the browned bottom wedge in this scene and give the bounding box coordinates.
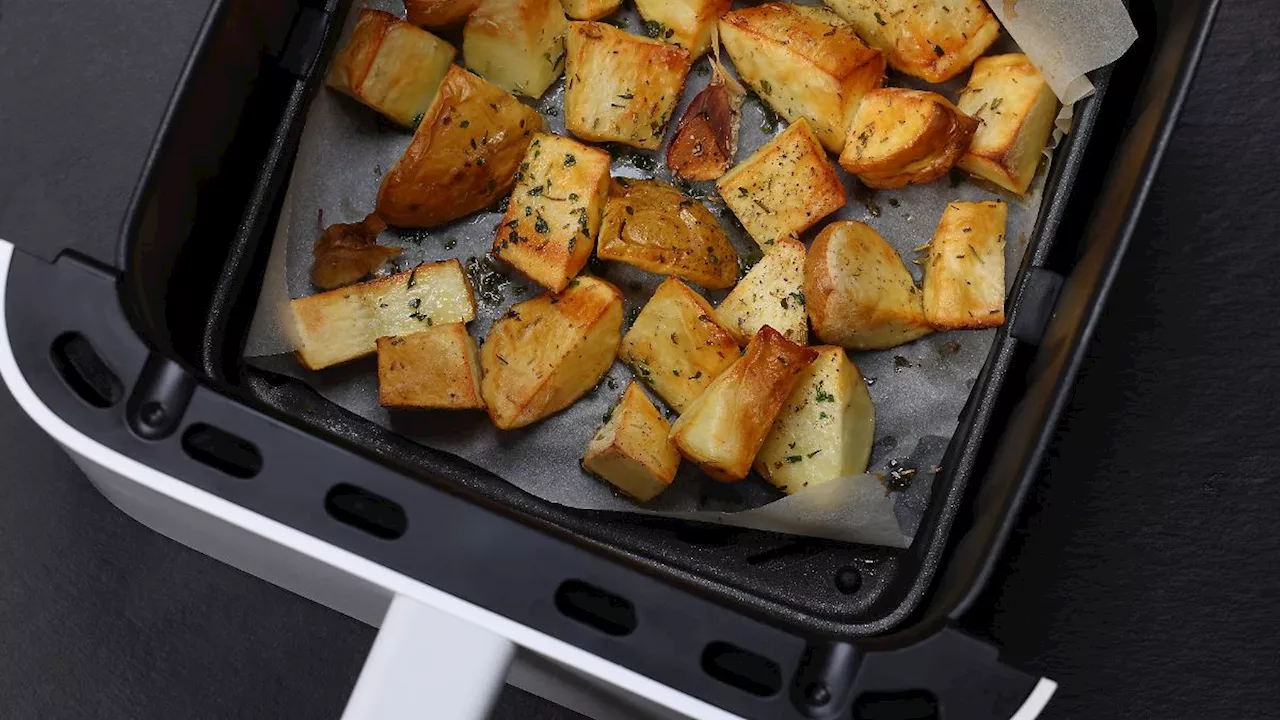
[755,345,876,495]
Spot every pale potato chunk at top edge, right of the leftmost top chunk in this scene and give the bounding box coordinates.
[462,0,568,97]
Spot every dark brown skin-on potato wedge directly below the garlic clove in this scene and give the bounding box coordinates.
[595,178,737,290]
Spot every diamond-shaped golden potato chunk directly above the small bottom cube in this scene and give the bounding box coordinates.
[620,278,739,413]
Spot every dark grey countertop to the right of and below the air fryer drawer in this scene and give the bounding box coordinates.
[0,0,1280,720]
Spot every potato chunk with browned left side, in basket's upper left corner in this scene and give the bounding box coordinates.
[325,9,457,128]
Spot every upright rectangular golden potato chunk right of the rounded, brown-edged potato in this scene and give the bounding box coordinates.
[924,200,1009,331]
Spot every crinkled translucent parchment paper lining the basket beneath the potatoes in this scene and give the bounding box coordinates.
[246,0,1136,547]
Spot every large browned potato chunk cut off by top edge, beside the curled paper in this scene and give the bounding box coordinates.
[823,0,1000,82]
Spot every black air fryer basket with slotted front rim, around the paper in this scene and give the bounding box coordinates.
[6,0,1216,716]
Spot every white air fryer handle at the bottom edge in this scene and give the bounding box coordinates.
[342,594,515,720]
